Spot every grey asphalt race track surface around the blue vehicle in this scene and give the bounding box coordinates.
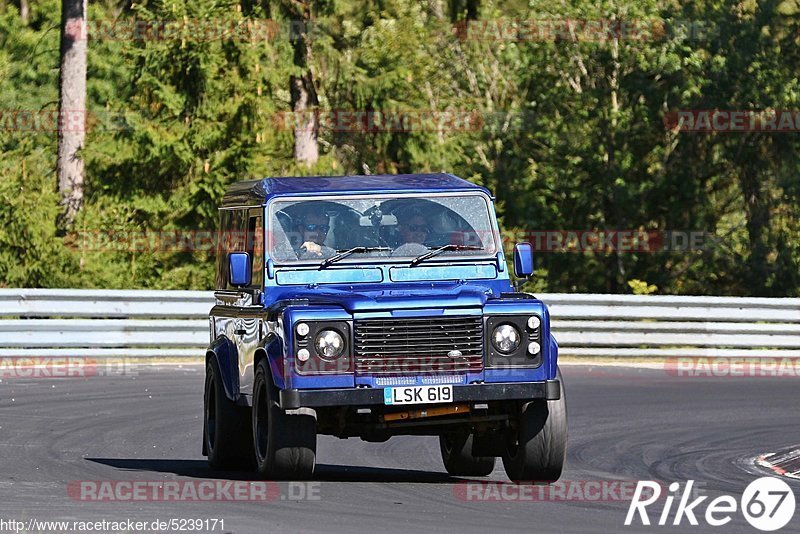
[0,365,800,533]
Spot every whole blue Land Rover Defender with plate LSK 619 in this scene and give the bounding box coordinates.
[203,174,567,481]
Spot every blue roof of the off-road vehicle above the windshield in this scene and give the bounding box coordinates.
[222,173,491,206]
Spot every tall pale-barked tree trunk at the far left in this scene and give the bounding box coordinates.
[58,0,87,229]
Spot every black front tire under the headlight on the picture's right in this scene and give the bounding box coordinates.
[503,371,567,483]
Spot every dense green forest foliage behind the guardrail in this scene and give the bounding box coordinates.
[0,0,800,296]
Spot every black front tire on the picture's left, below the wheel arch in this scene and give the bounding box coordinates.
[252,360,317,480]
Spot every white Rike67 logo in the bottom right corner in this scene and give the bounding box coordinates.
[625,477,795,532]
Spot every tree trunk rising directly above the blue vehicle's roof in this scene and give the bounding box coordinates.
[289,2,319,167]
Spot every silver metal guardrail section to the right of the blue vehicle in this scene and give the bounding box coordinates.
[539,293,800,357]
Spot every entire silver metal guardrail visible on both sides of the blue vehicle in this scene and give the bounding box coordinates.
[0,289,800,358]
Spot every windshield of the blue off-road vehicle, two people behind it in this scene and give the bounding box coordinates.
[267,193,498,266]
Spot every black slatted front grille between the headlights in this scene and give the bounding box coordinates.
[354,317,483,375]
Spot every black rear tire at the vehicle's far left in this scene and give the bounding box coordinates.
[203,358,253,469]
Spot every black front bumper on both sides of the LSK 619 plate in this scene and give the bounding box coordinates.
[280,380,561,410]
